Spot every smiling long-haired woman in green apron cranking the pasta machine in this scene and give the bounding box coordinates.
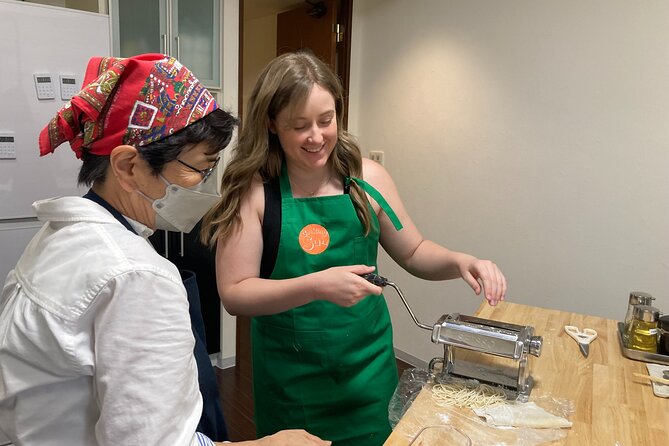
[203,53,506,446]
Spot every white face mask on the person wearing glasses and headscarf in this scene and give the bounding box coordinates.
[137,175,221,232]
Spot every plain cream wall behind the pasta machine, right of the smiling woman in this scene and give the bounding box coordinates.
[349,0,669,361]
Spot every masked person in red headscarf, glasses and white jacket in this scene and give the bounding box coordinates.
[0,54,327,446]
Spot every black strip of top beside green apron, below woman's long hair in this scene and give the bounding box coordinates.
[260,177,281,279]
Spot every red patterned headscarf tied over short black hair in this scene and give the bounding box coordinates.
[39,54,218,158]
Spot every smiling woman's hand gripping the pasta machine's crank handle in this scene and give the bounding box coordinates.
[314,265,383,307]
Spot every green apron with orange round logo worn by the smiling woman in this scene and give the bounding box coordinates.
[251,164,401,446]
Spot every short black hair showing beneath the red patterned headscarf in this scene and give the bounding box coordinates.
[78,109,238,186]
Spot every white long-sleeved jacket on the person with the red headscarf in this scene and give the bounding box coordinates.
[0,197,208,446]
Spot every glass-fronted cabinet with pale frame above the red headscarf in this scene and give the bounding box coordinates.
[110,0,221,89]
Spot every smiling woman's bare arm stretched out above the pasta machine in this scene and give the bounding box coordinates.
[363,159,506,305]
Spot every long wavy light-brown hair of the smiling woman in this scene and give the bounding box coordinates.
[200,52,372,246]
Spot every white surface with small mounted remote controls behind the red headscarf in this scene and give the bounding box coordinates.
[0,0,111,282]
